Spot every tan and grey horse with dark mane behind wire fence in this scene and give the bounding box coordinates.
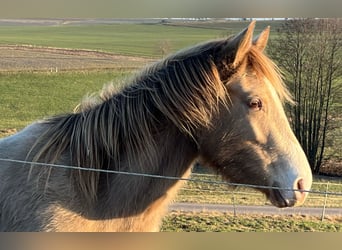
[0,21,312,232]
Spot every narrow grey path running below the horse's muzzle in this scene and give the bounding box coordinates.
[169,203,342,216]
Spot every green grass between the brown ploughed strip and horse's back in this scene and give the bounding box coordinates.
[0,71,131,129]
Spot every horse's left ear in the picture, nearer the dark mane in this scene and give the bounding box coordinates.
[229,20,255,67]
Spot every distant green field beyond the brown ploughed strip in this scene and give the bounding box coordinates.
[0,21,281,57]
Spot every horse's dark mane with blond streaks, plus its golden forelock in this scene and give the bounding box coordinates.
[32,39,291,202]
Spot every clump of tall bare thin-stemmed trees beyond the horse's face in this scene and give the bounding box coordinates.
[270,19,342,173]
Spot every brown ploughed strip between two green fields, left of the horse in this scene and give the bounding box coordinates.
[0,45,151,72]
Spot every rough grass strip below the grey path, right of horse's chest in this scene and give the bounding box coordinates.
[161,212,342,232]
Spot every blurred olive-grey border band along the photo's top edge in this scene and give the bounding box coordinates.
[0,0,342,18]
